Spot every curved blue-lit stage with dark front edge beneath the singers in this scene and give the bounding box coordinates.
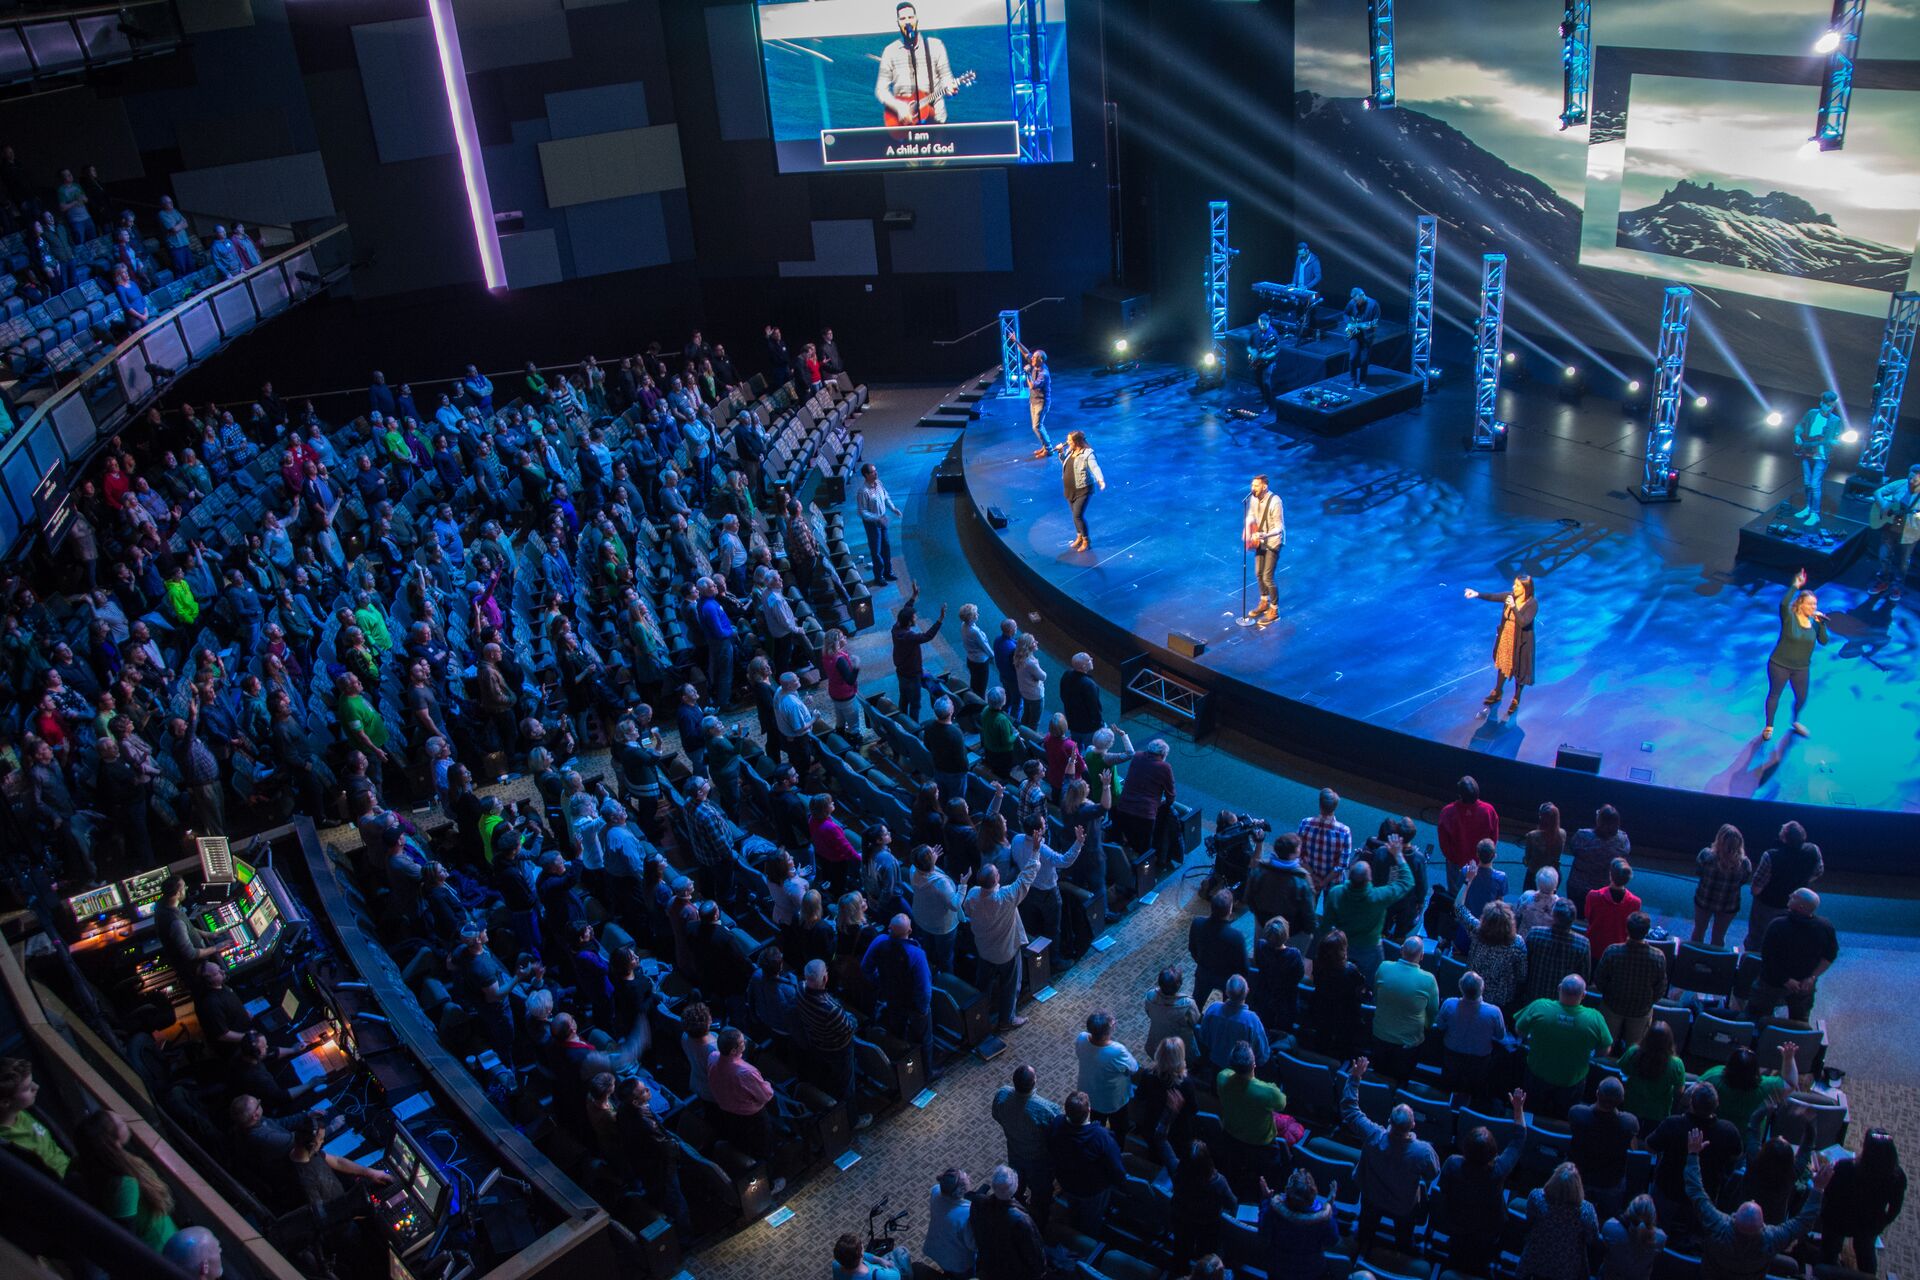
[962,355,1920,869]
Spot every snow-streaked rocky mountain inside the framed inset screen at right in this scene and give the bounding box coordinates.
[1619,178,1912,294]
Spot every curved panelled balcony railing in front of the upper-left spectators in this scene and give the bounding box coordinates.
[0,223,353,560]
